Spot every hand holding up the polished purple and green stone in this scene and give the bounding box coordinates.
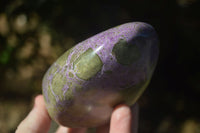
[16,95,138,133]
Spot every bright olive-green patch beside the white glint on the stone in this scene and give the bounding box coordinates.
[74,48,103,80]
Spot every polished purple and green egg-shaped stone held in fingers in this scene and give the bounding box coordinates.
[42,22,159,127]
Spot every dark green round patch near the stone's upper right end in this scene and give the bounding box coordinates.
[112,39,140,65]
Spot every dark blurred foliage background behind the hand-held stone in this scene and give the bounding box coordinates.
[0,0,200,133]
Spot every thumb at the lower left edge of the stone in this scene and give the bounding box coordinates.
[16,95,51,133]
